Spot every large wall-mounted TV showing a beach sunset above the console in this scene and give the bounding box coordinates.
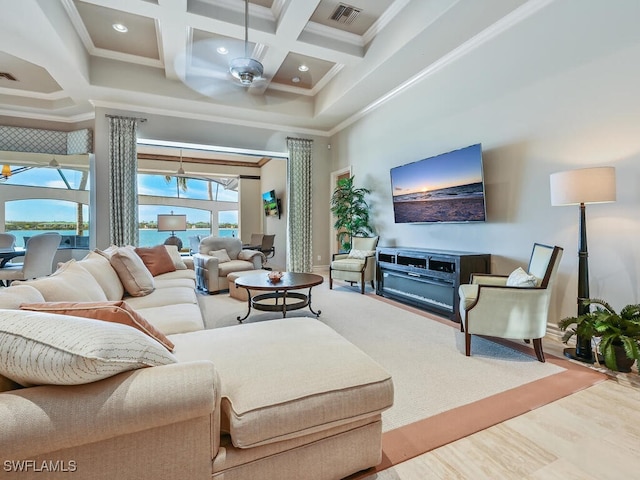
[391,144,486,223]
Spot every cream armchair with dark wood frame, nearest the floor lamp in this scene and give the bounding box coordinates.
[459,243,562,362]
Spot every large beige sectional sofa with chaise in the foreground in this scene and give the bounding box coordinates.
[0,246,393,480]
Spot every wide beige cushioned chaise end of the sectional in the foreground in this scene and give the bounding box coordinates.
[170,317,393,480]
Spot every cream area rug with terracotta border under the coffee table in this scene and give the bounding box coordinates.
[201,279,606,474]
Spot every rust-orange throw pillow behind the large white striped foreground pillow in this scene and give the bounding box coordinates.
[20,300,174,352]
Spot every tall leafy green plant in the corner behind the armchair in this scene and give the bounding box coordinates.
[331,177,373,251]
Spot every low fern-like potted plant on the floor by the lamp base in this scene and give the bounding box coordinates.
[558,299,640,372]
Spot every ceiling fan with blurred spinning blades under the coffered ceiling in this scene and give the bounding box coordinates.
[175,0,266,97]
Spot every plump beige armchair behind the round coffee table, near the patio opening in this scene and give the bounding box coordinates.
[193,236,264,293]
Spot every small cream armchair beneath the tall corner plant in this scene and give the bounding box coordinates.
[329,237,380,295]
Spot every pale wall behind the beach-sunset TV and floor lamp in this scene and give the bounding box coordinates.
[331,1,640,325]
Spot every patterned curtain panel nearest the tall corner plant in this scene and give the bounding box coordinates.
[287,138,313,273]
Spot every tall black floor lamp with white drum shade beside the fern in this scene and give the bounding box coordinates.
[550,167,616,363]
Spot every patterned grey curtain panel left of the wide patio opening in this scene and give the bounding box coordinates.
[109,116,139,245]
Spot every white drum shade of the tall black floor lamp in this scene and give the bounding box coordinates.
[550,167,616,207]
